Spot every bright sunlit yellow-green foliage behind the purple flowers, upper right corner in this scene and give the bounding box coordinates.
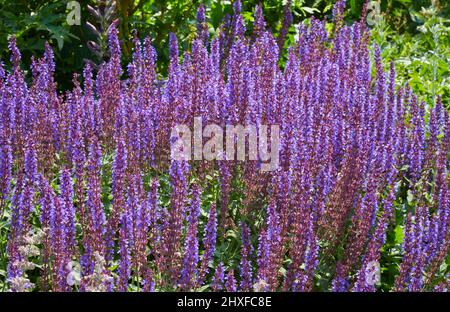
[372,1,450,109]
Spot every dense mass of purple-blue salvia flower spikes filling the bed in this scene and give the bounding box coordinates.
[0,1,450,291]
